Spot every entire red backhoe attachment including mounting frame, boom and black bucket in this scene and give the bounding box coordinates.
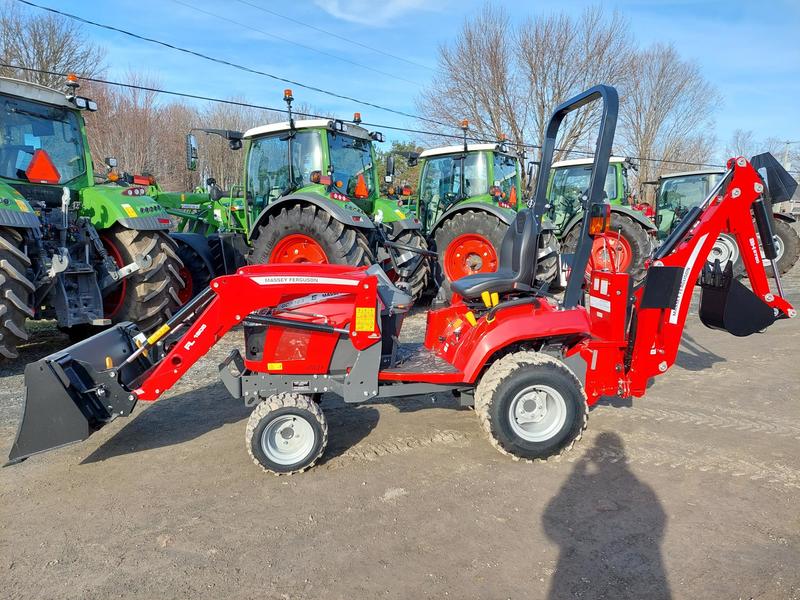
[581,158,796,401]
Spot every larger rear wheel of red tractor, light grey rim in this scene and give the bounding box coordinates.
[475,351,589,461]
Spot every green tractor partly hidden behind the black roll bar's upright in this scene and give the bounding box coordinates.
[548,157,656,284]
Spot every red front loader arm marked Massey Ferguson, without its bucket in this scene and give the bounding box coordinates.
[133,265,378,401]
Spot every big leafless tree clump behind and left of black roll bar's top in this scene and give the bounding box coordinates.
[418,4,632,156]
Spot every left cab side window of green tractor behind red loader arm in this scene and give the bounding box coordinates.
[247,131,322,205]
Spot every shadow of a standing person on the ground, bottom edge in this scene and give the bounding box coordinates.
[542,432,672,600]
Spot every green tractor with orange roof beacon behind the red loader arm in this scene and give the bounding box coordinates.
[170,90,430,298]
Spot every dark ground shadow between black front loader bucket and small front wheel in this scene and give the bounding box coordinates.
[81,383,252,464]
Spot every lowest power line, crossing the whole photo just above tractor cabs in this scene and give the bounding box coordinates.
[0,63,800,174]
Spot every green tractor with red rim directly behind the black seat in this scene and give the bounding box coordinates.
[406,128,558,304]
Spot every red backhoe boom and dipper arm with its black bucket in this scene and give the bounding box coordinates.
[625,158,796,396]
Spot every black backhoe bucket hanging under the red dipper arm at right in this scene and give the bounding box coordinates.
[700,261,776,337]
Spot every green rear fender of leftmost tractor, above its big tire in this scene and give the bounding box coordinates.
[80,185,170,230]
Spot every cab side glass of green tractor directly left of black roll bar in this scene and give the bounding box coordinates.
[420,152,489,205]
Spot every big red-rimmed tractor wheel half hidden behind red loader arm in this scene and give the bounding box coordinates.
[250,204,374,267]
